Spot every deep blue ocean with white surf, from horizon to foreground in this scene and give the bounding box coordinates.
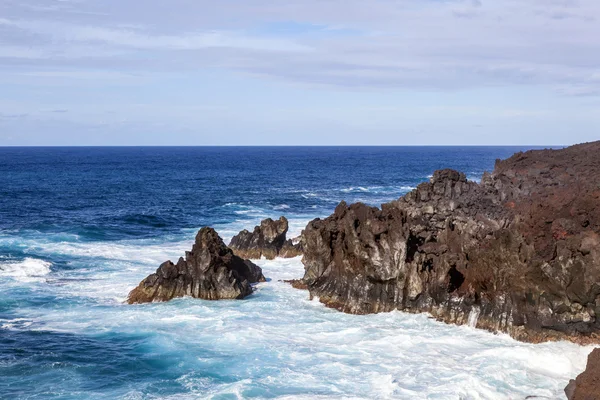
[0,147,591,399]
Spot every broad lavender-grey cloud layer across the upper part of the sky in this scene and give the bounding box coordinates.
[0,0,600,96]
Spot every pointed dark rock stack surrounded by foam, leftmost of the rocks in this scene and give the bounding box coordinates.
[127,228,265,304]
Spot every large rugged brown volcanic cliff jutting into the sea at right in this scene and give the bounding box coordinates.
[302,142,600,343]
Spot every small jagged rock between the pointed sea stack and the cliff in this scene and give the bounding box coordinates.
[229,216,302,260]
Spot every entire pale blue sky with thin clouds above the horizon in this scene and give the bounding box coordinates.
[0,0,600,146]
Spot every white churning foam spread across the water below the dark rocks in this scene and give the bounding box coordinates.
[4,250,591,399]
